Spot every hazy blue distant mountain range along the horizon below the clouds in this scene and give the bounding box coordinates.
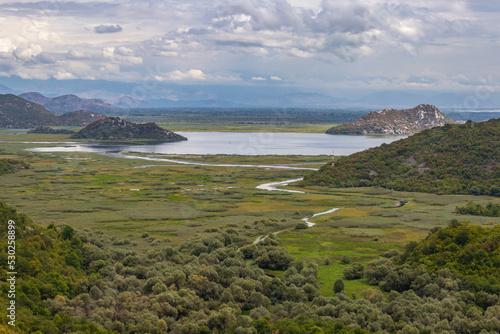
[0,80,500,111]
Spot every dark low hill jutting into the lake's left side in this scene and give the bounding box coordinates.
[71,117,187,142]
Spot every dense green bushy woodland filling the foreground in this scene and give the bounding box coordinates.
[0,204,500,334]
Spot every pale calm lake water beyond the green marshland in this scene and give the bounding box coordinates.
[32,132,406,155]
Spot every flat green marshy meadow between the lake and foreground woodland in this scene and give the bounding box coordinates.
[0,130,495,295]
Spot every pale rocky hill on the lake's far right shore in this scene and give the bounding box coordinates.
[326,104,455,135]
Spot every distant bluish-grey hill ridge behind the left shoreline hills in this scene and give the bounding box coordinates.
[19,92,120,114]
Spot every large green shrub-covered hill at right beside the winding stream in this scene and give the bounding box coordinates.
[302,119,500,195]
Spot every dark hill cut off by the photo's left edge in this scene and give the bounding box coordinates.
[0,94,61,129]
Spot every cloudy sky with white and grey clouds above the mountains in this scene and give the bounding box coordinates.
[0,0,500,103]
